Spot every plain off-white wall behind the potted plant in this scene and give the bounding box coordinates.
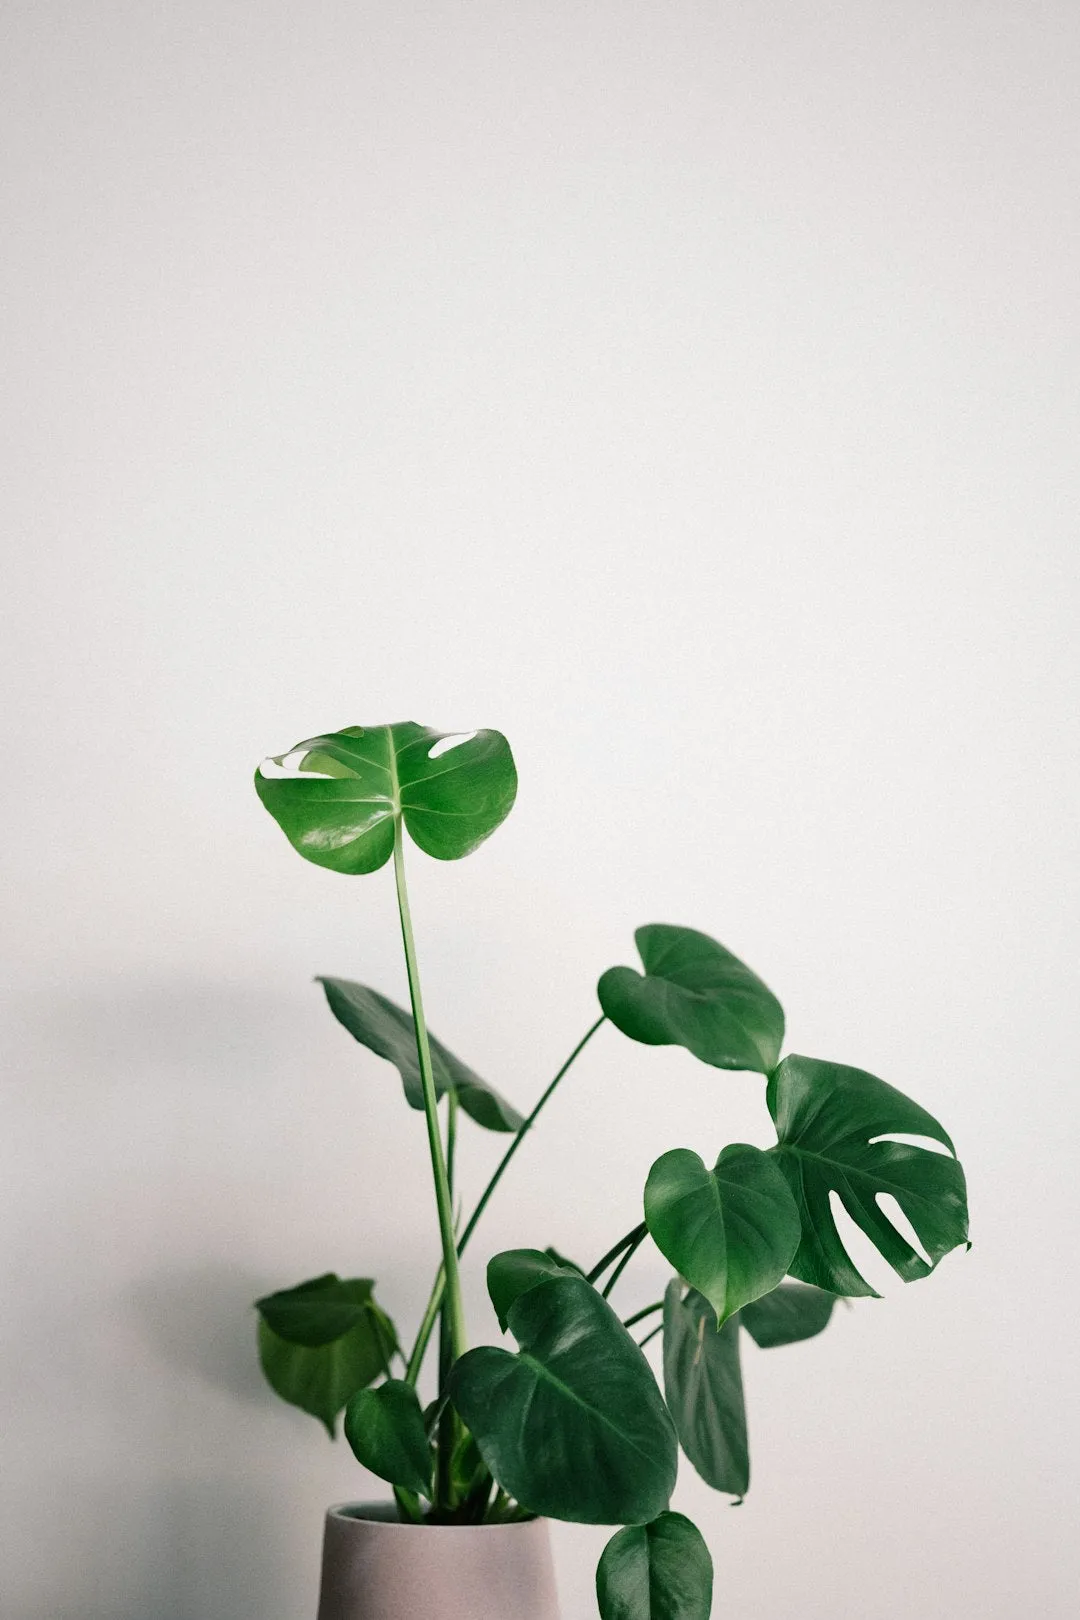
[0,0,1080,1620]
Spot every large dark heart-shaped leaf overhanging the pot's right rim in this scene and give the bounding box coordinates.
[450,1277,678,1524]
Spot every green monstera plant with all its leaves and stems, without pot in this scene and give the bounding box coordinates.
[256,723,967,1620]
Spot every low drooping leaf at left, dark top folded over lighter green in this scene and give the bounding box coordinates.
[257,1272,397,1439]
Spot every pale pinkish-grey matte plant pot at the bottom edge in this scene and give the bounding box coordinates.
[319,1502,559,1620]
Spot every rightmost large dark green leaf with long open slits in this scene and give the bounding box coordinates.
[766,1058,968,1298]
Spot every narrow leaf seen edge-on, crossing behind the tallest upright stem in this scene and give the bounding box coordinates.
[317,978,525,1131]
